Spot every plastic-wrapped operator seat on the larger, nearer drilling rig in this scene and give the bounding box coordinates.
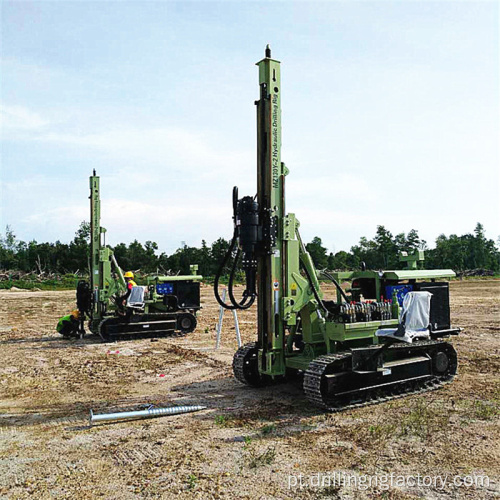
[375,292,432,344]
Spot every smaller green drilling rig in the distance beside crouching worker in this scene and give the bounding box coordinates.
[76,170,203,341]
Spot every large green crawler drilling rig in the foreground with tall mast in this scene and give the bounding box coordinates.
[214,46,460,411]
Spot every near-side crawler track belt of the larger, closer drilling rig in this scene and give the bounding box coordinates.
[303,340,457,412]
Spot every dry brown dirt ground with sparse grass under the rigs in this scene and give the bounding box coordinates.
[0,280,500,499]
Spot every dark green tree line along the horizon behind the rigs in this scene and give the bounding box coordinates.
[0,222,500,277]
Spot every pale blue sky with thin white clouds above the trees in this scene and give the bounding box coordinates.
[0,0,500,253]
